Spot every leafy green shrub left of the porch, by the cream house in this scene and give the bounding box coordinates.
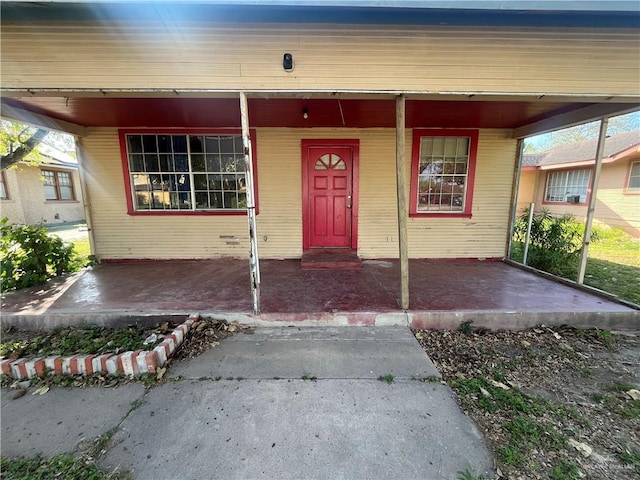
[0,217,82,291]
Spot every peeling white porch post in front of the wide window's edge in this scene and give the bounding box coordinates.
[240,92,260,315]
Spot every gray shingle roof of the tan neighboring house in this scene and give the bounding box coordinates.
[522,130,640,167]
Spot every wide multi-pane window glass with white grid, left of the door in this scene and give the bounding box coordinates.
[125,134,255,212]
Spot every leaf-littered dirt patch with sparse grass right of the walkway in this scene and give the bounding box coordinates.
[414,324,640,480]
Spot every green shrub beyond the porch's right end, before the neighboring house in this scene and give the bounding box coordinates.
[513,208,598,276]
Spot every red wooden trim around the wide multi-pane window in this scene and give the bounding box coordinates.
[118,128,260,217]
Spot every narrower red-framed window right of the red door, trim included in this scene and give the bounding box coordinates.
[409,130,478,216]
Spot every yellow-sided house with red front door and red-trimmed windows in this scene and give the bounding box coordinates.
[0,0,640,260]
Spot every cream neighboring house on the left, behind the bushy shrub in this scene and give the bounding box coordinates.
[0,145,84,225]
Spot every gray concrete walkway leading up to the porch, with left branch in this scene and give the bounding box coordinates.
[2,327,493,480]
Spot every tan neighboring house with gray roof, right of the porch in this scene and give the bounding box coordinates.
[518,130,640,237]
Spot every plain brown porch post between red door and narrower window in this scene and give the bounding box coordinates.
[396,94,409,310]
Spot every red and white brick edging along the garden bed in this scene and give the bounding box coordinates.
[0,314,200,380]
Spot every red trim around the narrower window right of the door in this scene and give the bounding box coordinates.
[409,128,478,218]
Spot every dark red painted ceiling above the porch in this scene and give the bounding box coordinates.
[2,94,638,134]
